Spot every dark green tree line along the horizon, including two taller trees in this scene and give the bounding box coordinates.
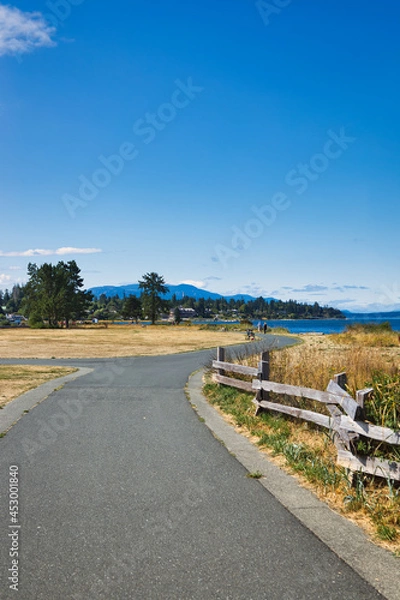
[0,261,344,327]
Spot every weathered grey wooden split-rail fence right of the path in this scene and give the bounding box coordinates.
[212,348,400,481]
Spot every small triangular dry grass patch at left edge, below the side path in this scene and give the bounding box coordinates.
[0,365,76,409]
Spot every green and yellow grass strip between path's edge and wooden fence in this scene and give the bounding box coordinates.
[203,382,400,557]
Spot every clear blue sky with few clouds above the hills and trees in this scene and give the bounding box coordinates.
[0,0,400,310]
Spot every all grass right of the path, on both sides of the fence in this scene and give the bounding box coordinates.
[204,331,400,556]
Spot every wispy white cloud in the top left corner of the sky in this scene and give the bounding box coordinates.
[0,4,56,56]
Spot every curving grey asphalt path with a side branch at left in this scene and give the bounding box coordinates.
[0,338,388,600]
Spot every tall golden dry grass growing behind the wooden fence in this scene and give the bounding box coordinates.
[231,330,400,430]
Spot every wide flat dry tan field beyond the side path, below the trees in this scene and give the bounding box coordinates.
[0,325,245,358]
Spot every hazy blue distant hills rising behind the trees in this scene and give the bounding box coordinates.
[90,283,276,302]
